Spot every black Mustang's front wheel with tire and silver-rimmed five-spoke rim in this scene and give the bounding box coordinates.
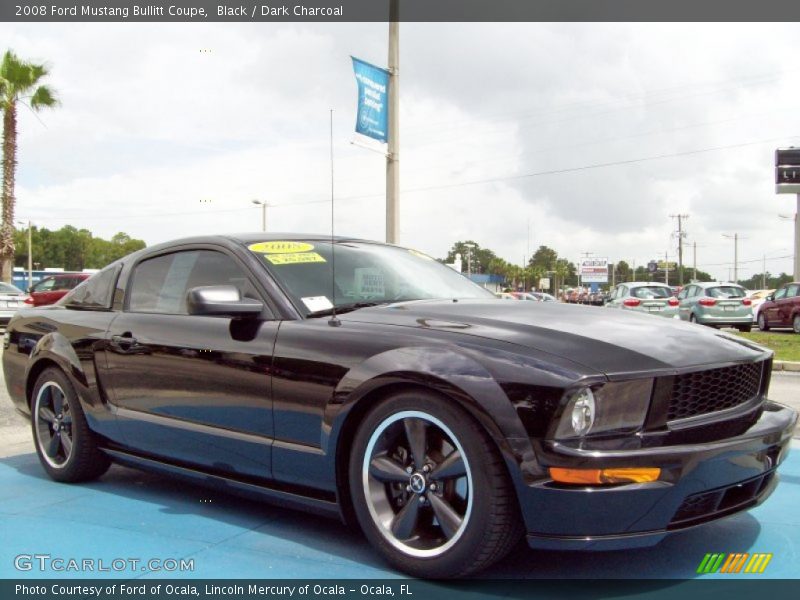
[349,391,523,579]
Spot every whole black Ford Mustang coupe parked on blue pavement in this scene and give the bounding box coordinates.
[3,234,797,577]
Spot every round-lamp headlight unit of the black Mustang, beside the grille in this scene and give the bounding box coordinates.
[554,379,653,439]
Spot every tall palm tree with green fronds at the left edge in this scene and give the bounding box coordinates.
[0,50,58,282]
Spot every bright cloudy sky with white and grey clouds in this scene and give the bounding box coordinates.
[0,23,800,278]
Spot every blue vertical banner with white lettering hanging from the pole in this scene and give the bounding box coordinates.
[350,56,389,144]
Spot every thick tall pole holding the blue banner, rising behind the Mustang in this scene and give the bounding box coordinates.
[386,0,400,244]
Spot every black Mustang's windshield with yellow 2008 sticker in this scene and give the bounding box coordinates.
[248,240,494,314]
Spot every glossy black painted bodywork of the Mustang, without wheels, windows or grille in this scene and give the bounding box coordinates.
[3,235,796,548]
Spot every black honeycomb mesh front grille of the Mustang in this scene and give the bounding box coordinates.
[667,362,768,421]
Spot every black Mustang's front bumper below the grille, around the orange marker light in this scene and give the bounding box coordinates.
[518,401,797,550]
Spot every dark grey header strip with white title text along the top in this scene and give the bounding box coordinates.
[7,0,800,22]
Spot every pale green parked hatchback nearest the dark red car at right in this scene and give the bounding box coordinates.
[678,281,753,332]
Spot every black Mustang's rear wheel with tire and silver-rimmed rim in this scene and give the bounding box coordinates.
[31,367,111,483]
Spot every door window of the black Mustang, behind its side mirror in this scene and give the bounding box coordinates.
[128,250,253,315]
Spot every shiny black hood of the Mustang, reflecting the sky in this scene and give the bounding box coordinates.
[341,299,770,375]
